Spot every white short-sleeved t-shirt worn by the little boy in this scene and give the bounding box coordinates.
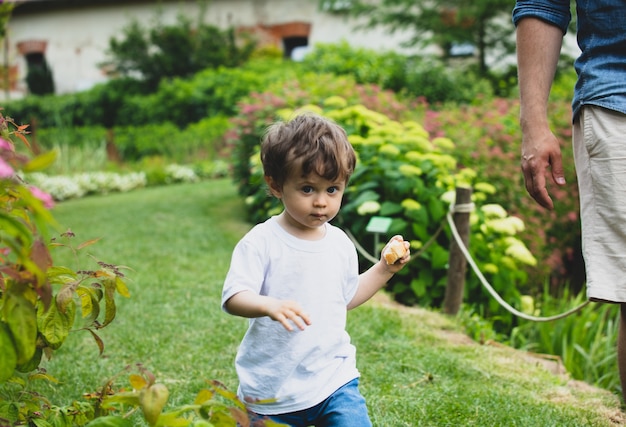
[222,217,359,415]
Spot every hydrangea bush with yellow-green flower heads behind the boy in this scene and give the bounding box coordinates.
[239,97,536,330]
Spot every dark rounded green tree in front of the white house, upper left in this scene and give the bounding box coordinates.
[101,9,255,89]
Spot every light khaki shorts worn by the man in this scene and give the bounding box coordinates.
[573,106,626,302]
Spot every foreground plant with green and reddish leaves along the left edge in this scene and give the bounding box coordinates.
[0,111,129,425]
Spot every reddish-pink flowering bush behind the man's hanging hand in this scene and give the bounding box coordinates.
[423,94,584,295]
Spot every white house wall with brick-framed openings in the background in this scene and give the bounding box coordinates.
[0,0,420,98]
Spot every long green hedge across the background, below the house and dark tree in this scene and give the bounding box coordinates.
[4,42,493,129]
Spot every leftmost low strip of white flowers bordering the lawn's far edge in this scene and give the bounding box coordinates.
[26,172,147,201]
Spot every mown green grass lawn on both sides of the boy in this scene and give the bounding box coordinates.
[37,180,626,427]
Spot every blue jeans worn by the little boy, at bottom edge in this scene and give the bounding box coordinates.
[254,378,372,427]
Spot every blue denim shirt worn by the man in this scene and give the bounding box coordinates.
[513,0,626,117]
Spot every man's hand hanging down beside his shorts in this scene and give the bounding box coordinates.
[522,131,565,209]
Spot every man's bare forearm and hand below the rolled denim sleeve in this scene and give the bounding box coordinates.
[517,18,565,209]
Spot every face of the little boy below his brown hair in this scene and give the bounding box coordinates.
[266,173,346,238]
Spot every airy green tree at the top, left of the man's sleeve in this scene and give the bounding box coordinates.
[320,0,515,75]
